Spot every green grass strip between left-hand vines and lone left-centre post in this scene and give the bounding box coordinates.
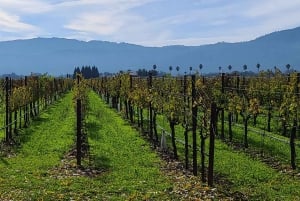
[0,93,75,200]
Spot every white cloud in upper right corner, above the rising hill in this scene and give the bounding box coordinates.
[233,0,300,40]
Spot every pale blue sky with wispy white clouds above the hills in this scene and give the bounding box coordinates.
[0,0,300,46]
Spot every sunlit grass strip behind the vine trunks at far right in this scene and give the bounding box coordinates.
[218,111,300,168]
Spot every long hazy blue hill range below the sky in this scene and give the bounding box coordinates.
[0,27,300,75]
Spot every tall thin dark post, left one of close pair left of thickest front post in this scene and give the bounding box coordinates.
[183,75,189,169]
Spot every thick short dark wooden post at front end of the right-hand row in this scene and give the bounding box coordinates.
[207,102,217,186]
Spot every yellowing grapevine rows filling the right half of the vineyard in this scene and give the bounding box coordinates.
[89,72,300,185]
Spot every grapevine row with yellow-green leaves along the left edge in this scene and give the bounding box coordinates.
[0,76,73,143]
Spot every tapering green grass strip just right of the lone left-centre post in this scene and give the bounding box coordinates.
[87,93,176,200]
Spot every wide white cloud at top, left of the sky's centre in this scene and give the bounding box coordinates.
[64,0,155,37]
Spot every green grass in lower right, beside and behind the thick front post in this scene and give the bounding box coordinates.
[158,113,300,200]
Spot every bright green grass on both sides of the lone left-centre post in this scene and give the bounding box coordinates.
[0,93,176,200]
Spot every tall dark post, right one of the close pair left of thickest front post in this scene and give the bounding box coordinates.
[192,75,198,176]
